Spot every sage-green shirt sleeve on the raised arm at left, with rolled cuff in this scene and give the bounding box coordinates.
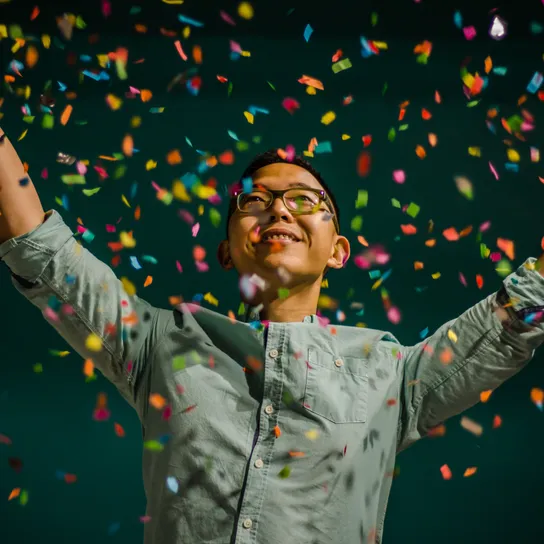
[0,210,172,403]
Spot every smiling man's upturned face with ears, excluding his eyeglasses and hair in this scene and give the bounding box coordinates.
[224,163,349,287]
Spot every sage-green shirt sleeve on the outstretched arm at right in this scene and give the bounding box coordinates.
[397,257,544,451]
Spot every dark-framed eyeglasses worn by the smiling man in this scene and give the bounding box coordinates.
[235,188,340,232]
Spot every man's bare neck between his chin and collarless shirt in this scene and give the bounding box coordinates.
[254,277,322,323]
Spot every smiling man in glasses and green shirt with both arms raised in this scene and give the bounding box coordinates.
[0,129,544,544]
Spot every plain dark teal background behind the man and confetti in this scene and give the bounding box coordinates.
[0,0,544,544]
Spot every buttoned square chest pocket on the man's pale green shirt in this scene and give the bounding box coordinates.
[304,348,368,423]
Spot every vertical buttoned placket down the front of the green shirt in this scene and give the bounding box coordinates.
[235,323,285,544]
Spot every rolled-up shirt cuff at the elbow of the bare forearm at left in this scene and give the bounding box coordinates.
[0,210,74,283]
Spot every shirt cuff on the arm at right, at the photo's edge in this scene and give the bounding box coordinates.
[503,257,544,326]
